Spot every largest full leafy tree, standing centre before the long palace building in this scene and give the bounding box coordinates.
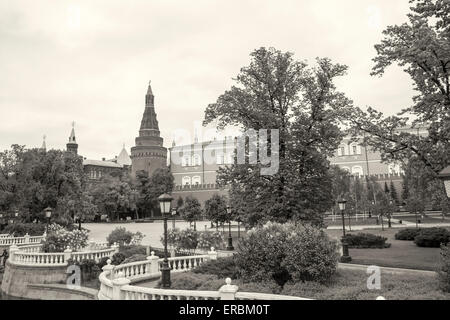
[204,47,349,226]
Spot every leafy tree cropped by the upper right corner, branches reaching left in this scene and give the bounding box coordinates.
[342,0,450,175]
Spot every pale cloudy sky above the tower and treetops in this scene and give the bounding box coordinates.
[0,0,413,159]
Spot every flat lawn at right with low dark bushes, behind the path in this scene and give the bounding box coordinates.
[326,228,440,271]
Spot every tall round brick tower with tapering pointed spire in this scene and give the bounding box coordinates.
[131,82,167,178]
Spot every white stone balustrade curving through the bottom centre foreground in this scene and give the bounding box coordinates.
[98,248,310,300]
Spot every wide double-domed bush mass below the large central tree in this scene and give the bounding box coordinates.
[235,223,339,286]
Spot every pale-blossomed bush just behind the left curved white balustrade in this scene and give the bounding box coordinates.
[42,224,89,252]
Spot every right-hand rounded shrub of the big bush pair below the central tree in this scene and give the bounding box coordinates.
[282,226,339,282]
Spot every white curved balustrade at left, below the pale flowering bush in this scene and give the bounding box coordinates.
[9,244,119,267]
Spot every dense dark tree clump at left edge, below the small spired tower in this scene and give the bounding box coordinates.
[0,145,92,222]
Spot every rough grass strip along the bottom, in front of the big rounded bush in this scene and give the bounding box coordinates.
[167,270,450,300]
